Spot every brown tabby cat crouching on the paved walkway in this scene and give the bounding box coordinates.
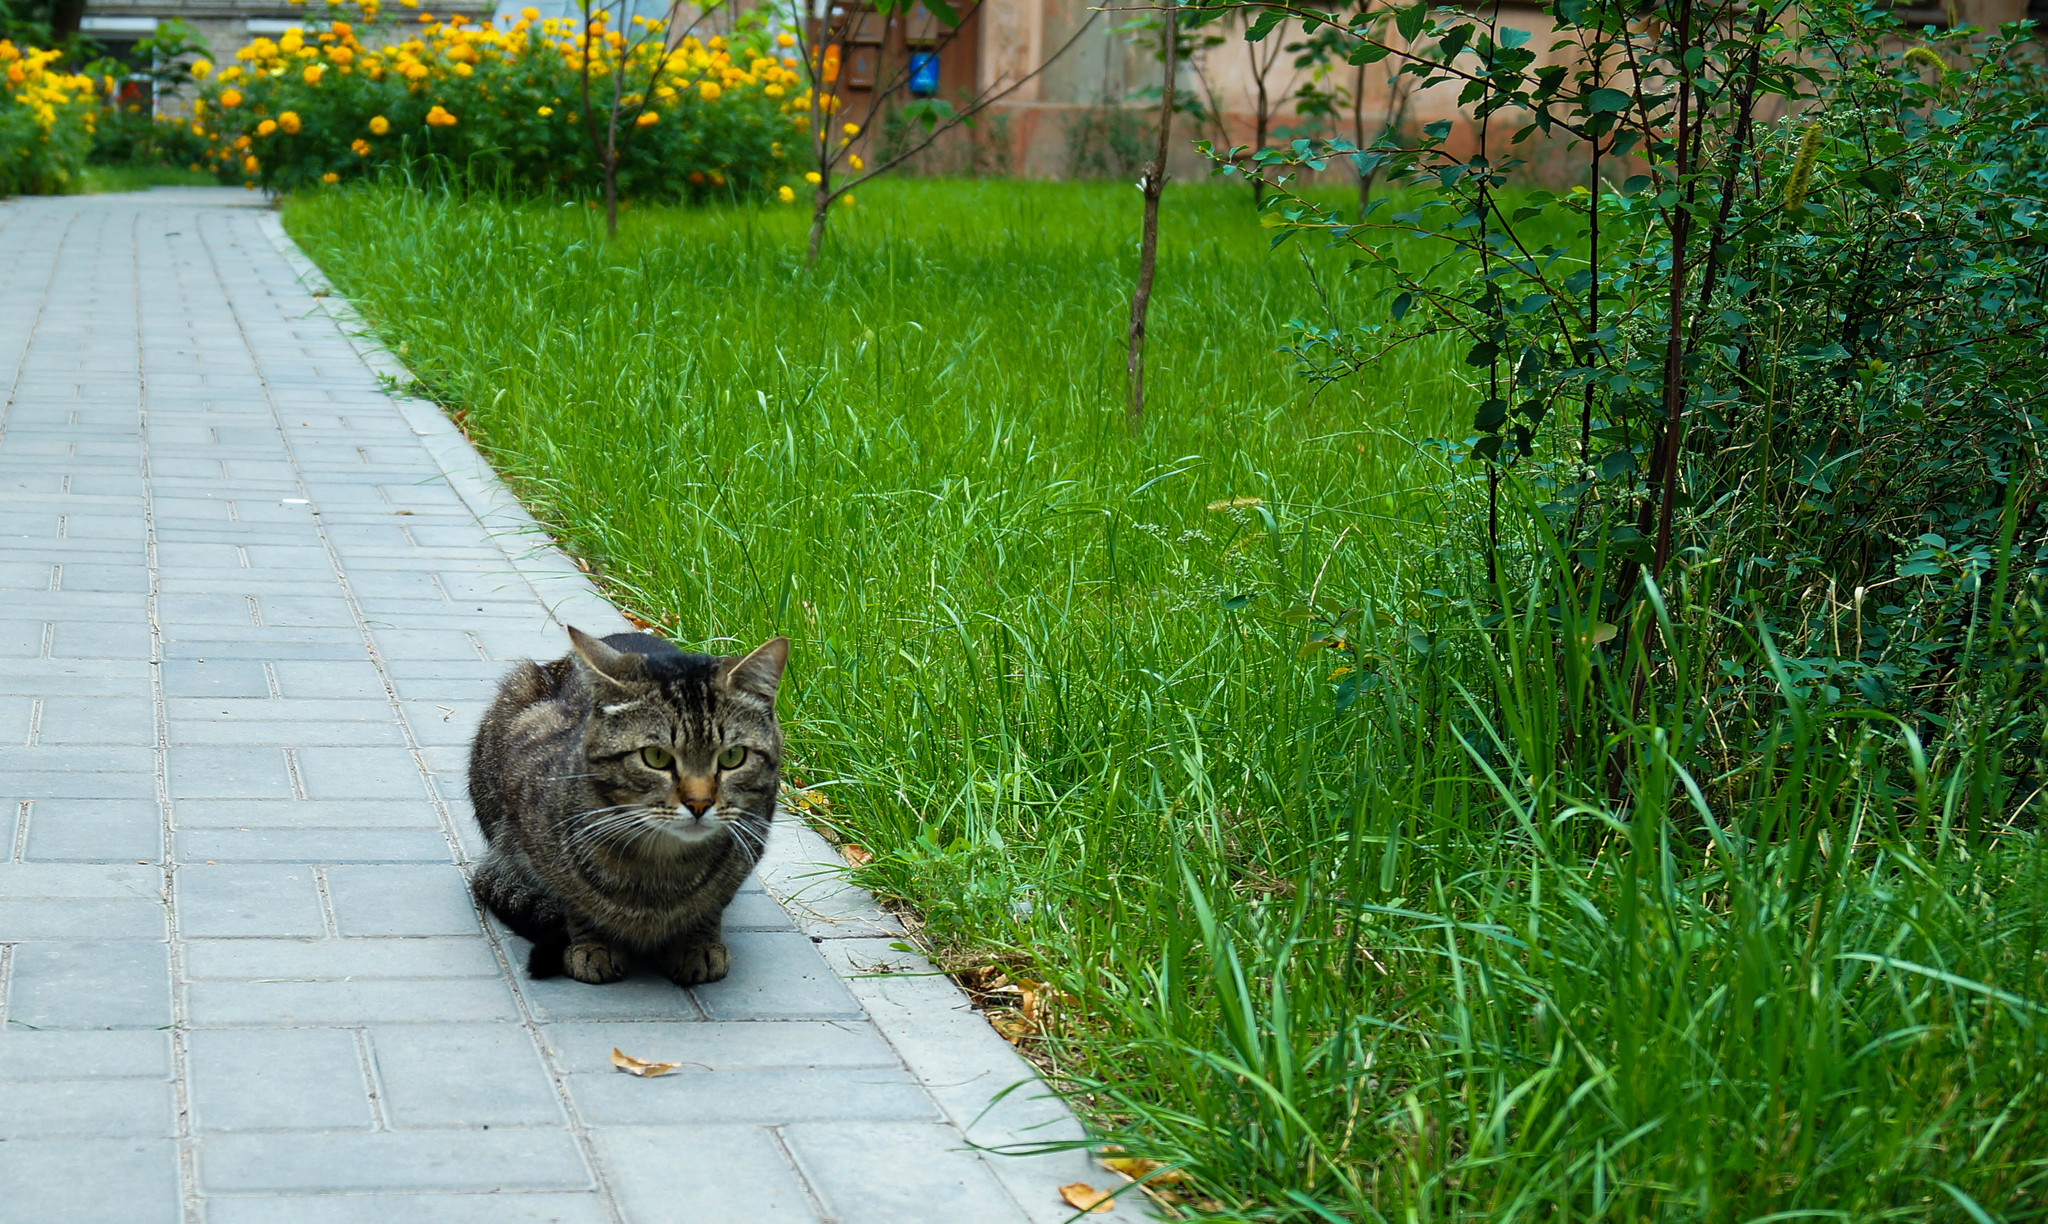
[469,628,788,987]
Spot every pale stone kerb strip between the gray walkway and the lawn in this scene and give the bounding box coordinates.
[258,211,1157,1224]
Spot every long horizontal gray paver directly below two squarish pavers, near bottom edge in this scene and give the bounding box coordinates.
[199,1128,592,1193]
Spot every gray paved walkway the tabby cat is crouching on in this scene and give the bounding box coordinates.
[0,190,1126,1224]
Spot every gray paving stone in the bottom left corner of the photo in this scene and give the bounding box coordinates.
[0,1138,184,1224]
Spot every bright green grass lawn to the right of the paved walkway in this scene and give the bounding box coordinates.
[287,182,2048,1222]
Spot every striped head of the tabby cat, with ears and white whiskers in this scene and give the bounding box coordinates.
[569,628,788,856]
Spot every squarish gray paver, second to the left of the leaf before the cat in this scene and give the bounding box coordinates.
[186,1028,377,1132]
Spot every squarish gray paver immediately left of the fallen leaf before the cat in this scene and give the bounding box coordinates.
[369,1023,567,1128]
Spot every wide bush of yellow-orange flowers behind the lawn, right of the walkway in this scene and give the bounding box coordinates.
[193,0,805,199]
